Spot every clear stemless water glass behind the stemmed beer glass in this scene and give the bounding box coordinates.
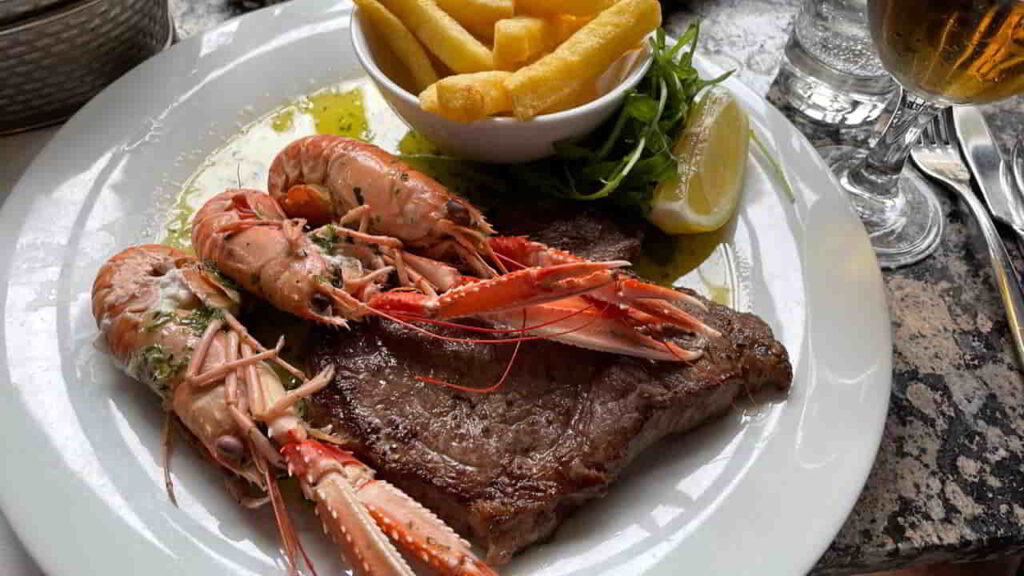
[776,0,897,126]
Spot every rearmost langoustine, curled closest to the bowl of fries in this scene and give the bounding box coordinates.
[267,134,715,334]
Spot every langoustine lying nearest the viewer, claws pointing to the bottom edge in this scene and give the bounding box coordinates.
[92,245,495,576]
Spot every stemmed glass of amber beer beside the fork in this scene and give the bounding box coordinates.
[821,0,1024,269]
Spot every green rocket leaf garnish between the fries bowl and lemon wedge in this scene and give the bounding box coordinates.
[401,24,731,211]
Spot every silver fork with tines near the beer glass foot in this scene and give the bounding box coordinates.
[910,114,1024,361]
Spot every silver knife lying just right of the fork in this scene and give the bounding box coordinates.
[952,107,1024,245]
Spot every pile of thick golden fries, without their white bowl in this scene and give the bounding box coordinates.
[354,0,662,122]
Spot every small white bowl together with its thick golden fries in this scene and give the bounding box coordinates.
[350,0,662,163]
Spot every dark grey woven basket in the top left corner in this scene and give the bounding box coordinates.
[0,0,174,133]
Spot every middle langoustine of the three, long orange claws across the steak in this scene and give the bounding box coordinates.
[193,183,698,361]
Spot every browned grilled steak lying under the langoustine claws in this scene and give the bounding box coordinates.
[309,206,792,564]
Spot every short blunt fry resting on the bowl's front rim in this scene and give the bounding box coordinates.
[432,71,512,122]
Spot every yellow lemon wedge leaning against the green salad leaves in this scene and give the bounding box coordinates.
[647,86,750,234]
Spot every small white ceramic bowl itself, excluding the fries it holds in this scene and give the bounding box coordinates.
[349,8,651,164]
